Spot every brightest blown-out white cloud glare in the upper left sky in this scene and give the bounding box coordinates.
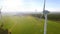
[2,0,23,11]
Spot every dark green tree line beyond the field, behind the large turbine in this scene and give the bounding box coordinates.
[31,13,60,21]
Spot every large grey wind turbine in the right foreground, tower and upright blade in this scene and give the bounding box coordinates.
[42,0,49,34]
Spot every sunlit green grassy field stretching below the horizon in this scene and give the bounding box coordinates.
[2,16,60,34]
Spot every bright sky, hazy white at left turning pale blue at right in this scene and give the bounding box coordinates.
[0,0,60,12]
